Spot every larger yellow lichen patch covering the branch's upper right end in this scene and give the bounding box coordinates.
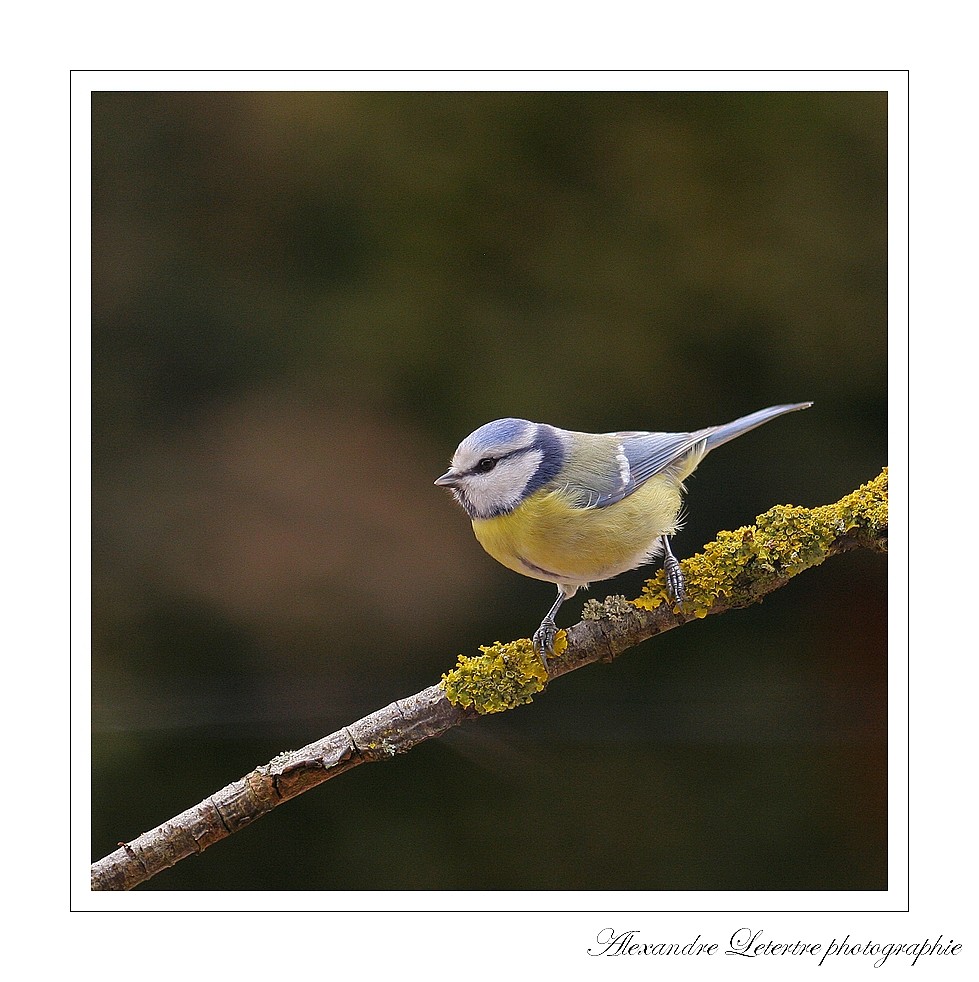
[633,467,887,617]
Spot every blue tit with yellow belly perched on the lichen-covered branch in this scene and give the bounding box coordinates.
[435,402,812,665]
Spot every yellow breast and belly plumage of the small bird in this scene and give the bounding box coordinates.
[473,476,681,586]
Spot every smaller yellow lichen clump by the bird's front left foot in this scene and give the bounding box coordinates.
[440,631,568,715]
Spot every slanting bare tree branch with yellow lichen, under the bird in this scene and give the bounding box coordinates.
[92,468,887,890]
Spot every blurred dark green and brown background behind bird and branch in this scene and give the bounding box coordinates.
[92,92,887,890]
